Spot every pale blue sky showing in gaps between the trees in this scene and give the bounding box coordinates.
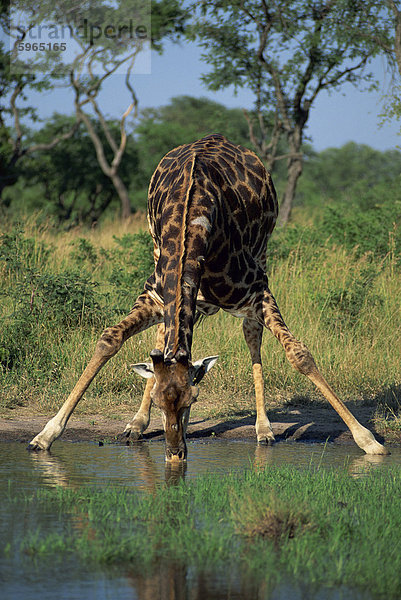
[24,43,401,151]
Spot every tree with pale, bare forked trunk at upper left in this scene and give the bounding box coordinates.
[2,0,185,218]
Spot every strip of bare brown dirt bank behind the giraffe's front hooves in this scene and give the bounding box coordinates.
[0,405,394,444]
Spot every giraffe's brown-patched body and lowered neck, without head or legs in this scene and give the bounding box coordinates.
[147,134,277,356]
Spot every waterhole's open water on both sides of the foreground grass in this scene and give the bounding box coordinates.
[0,440,401,600]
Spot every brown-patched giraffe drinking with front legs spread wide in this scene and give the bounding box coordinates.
[28,134,388,462]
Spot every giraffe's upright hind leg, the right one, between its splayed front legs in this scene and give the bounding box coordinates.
[242,319,275,445]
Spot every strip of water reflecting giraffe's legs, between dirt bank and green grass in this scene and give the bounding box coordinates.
[6,440,401,491]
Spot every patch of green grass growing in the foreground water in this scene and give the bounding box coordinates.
[8,467,401,599]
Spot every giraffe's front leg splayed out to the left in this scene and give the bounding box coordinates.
[28,291,163,450]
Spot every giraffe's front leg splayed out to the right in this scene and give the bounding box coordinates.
[263,290,390,455]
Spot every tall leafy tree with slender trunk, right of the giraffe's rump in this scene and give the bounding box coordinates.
[190,0,392,224]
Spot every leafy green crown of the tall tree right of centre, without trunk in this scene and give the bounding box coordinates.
[189,0,392,97]
